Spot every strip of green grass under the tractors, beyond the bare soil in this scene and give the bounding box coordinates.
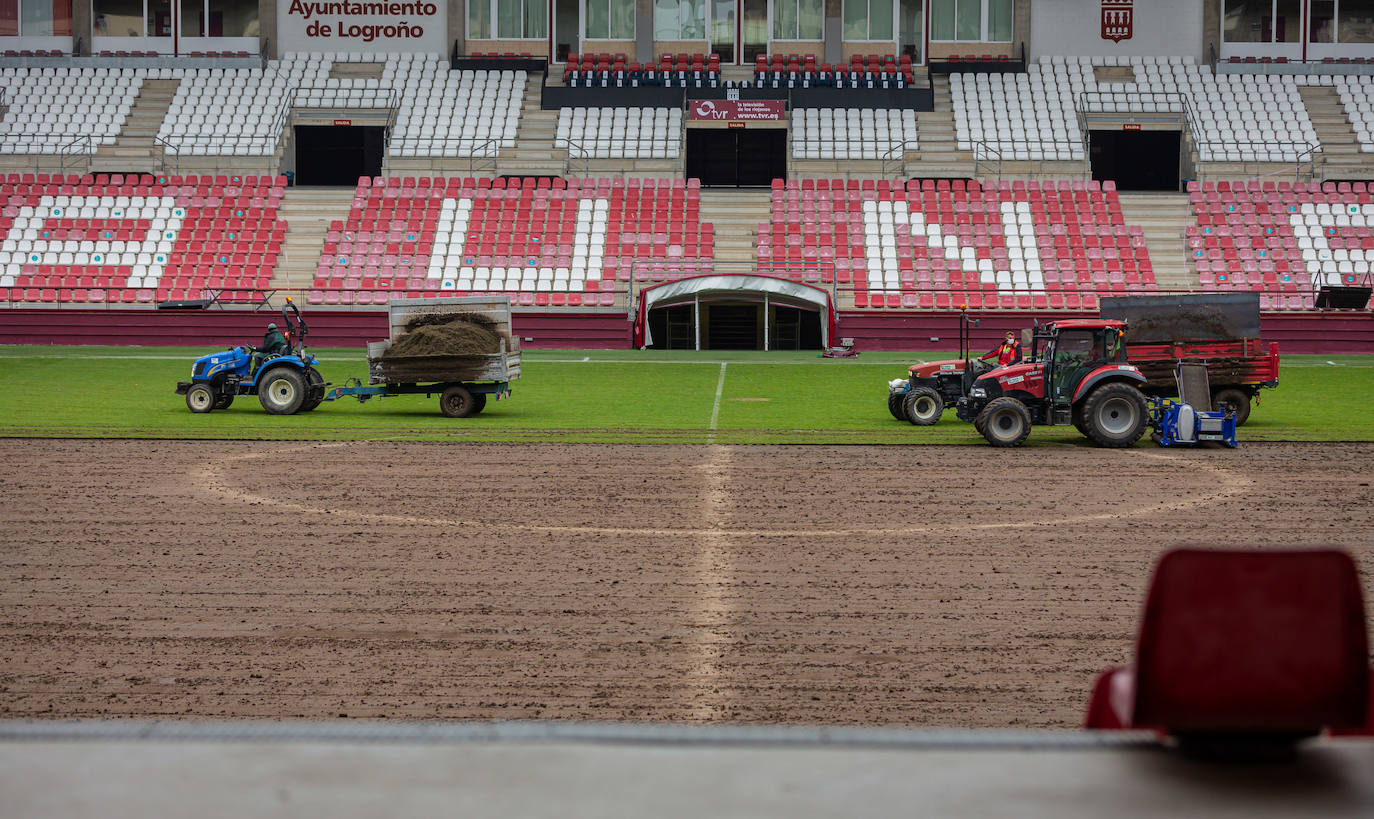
[0,346,1374,445]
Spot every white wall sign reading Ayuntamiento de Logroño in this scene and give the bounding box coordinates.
[276,0,448,54]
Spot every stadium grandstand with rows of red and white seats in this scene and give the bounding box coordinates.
[0,0,1374,349]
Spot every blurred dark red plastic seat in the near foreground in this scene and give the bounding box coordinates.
[1085,548,1370,738]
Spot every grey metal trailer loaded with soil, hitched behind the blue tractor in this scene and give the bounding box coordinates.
[324,295,521,418]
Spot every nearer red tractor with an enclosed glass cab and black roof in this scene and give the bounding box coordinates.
[958,319,1149,447]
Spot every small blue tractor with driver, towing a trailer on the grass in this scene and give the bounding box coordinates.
[176,298,328,415]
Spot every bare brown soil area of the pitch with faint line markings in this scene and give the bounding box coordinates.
[0,440,1374,728]
